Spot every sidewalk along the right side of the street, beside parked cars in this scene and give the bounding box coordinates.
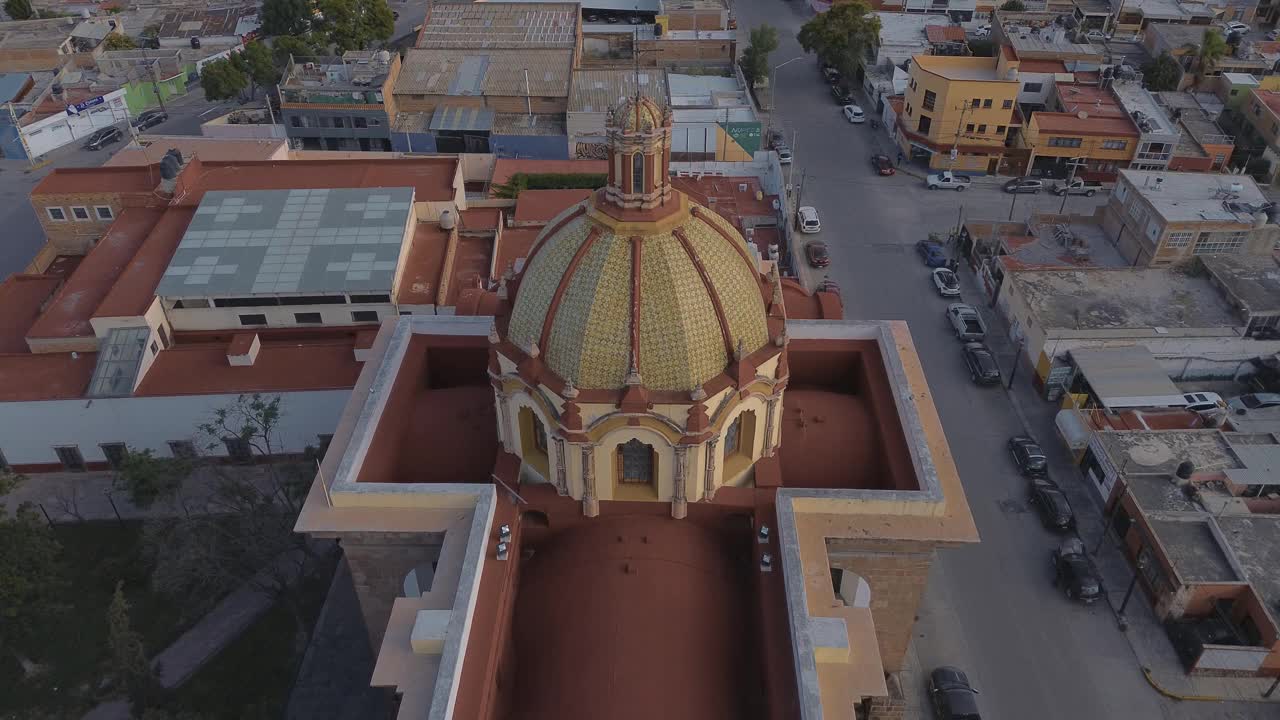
[961,262,1280,703]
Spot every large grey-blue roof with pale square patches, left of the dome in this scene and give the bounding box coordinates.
[156,187,413,297]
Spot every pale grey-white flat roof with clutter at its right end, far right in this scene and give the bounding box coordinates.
[1120,169,1270,225]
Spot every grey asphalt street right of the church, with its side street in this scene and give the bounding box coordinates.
[735,0,1276,720]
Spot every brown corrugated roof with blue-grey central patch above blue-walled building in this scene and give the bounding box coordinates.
[394,49,573,97]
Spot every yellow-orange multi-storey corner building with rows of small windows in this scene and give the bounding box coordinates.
[897,49,1021,174]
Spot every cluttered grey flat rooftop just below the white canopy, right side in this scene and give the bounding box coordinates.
[1094,429,1244,477]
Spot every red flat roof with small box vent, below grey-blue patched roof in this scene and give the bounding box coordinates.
[133,337,361,396]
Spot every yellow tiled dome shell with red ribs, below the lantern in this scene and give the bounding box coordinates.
[507,198,768,391]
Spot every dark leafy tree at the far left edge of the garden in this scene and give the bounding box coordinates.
[0,502,67,666]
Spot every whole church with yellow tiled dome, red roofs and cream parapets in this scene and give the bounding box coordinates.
[297,99,978,720]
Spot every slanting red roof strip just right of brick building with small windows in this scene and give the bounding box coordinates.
[28,208,164,338]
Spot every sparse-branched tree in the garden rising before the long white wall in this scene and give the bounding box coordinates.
[146,395,320,653]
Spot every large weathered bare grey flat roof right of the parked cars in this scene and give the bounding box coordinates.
[1009,265,1239,333]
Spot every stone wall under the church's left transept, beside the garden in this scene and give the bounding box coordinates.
[342,533,444,653]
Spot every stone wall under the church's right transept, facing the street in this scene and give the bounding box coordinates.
[827,539,934,673]
